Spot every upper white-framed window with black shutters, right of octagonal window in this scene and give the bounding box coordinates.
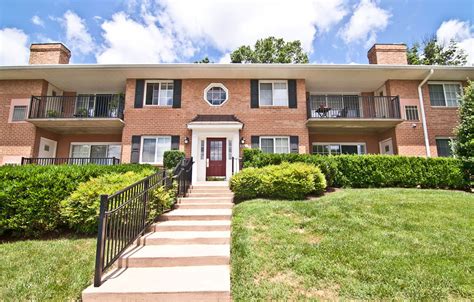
[258,81,288,106]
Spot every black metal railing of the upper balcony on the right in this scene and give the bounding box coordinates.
[307,95,400,119]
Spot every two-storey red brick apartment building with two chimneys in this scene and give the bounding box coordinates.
[0,43,474,181]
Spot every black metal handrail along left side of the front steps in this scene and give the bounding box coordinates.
[94,158,193,287]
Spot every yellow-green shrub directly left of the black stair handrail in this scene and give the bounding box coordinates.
[60,169,154,234]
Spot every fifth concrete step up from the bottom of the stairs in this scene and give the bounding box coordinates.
[158,209,232,221]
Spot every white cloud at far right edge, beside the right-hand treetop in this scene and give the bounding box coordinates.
[436,20,474,65]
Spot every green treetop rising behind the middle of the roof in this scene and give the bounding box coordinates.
[230,37,309,63]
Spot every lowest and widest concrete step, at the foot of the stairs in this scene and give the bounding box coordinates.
[82,265,230,302]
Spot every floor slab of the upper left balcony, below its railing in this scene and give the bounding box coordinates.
[27,118,124,134]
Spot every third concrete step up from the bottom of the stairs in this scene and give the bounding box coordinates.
[137,231,230,248]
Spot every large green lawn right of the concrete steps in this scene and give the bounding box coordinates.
[231,189,474,301]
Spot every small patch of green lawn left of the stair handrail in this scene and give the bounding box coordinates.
[0,236,96,301]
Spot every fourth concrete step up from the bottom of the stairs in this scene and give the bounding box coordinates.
[150,220,231,232]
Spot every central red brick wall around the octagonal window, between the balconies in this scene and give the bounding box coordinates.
[122,79,309,161]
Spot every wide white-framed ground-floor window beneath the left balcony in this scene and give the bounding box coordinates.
[70,143,122,159]
